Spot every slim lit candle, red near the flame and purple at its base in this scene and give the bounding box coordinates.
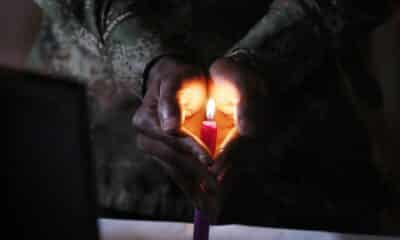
[193,99,217,240]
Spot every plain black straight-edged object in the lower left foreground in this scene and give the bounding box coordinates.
[0,69,97,240]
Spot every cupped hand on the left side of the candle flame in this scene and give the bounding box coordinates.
[133,57,216,218]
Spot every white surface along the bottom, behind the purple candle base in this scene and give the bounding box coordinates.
[98,219,400,240]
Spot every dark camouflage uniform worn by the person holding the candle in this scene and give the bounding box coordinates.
[35,0,390,231]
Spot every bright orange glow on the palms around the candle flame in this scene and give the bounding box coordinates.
[177,79,240,158]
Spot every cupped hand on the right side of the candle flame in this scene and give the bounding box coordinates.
[209,58,269,187]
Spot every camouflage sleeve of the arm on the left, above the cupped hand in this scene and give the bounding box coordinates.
[100,0,191,97]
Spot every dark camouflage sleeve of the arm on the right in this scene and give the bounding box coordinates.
[227,0,385,94]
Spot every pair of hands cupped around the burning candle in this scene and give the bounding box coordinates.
[133,57,267,219]
